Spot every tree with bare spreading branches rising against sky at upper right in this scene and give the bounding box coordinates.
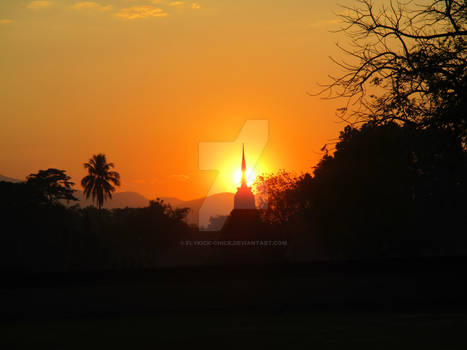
[321,0,467,146]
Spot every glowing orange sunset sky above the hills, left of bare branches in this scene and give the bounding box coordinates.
[0,0,352,200]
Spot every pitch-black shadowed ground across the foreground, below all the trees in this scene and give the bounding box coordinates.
[0,258,467,349]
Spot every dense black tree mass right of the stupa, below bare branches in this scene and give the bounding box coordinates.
[256,122,467,258]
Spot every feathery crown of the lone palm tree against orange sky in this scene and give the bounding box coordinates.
[81,153,120,209]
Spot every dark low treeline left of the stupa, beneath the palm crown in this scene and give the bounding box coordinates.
[0,179,192,271]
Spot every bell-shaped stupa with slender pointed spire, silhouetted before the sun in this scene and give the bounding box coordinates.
[221,145,264,238]
